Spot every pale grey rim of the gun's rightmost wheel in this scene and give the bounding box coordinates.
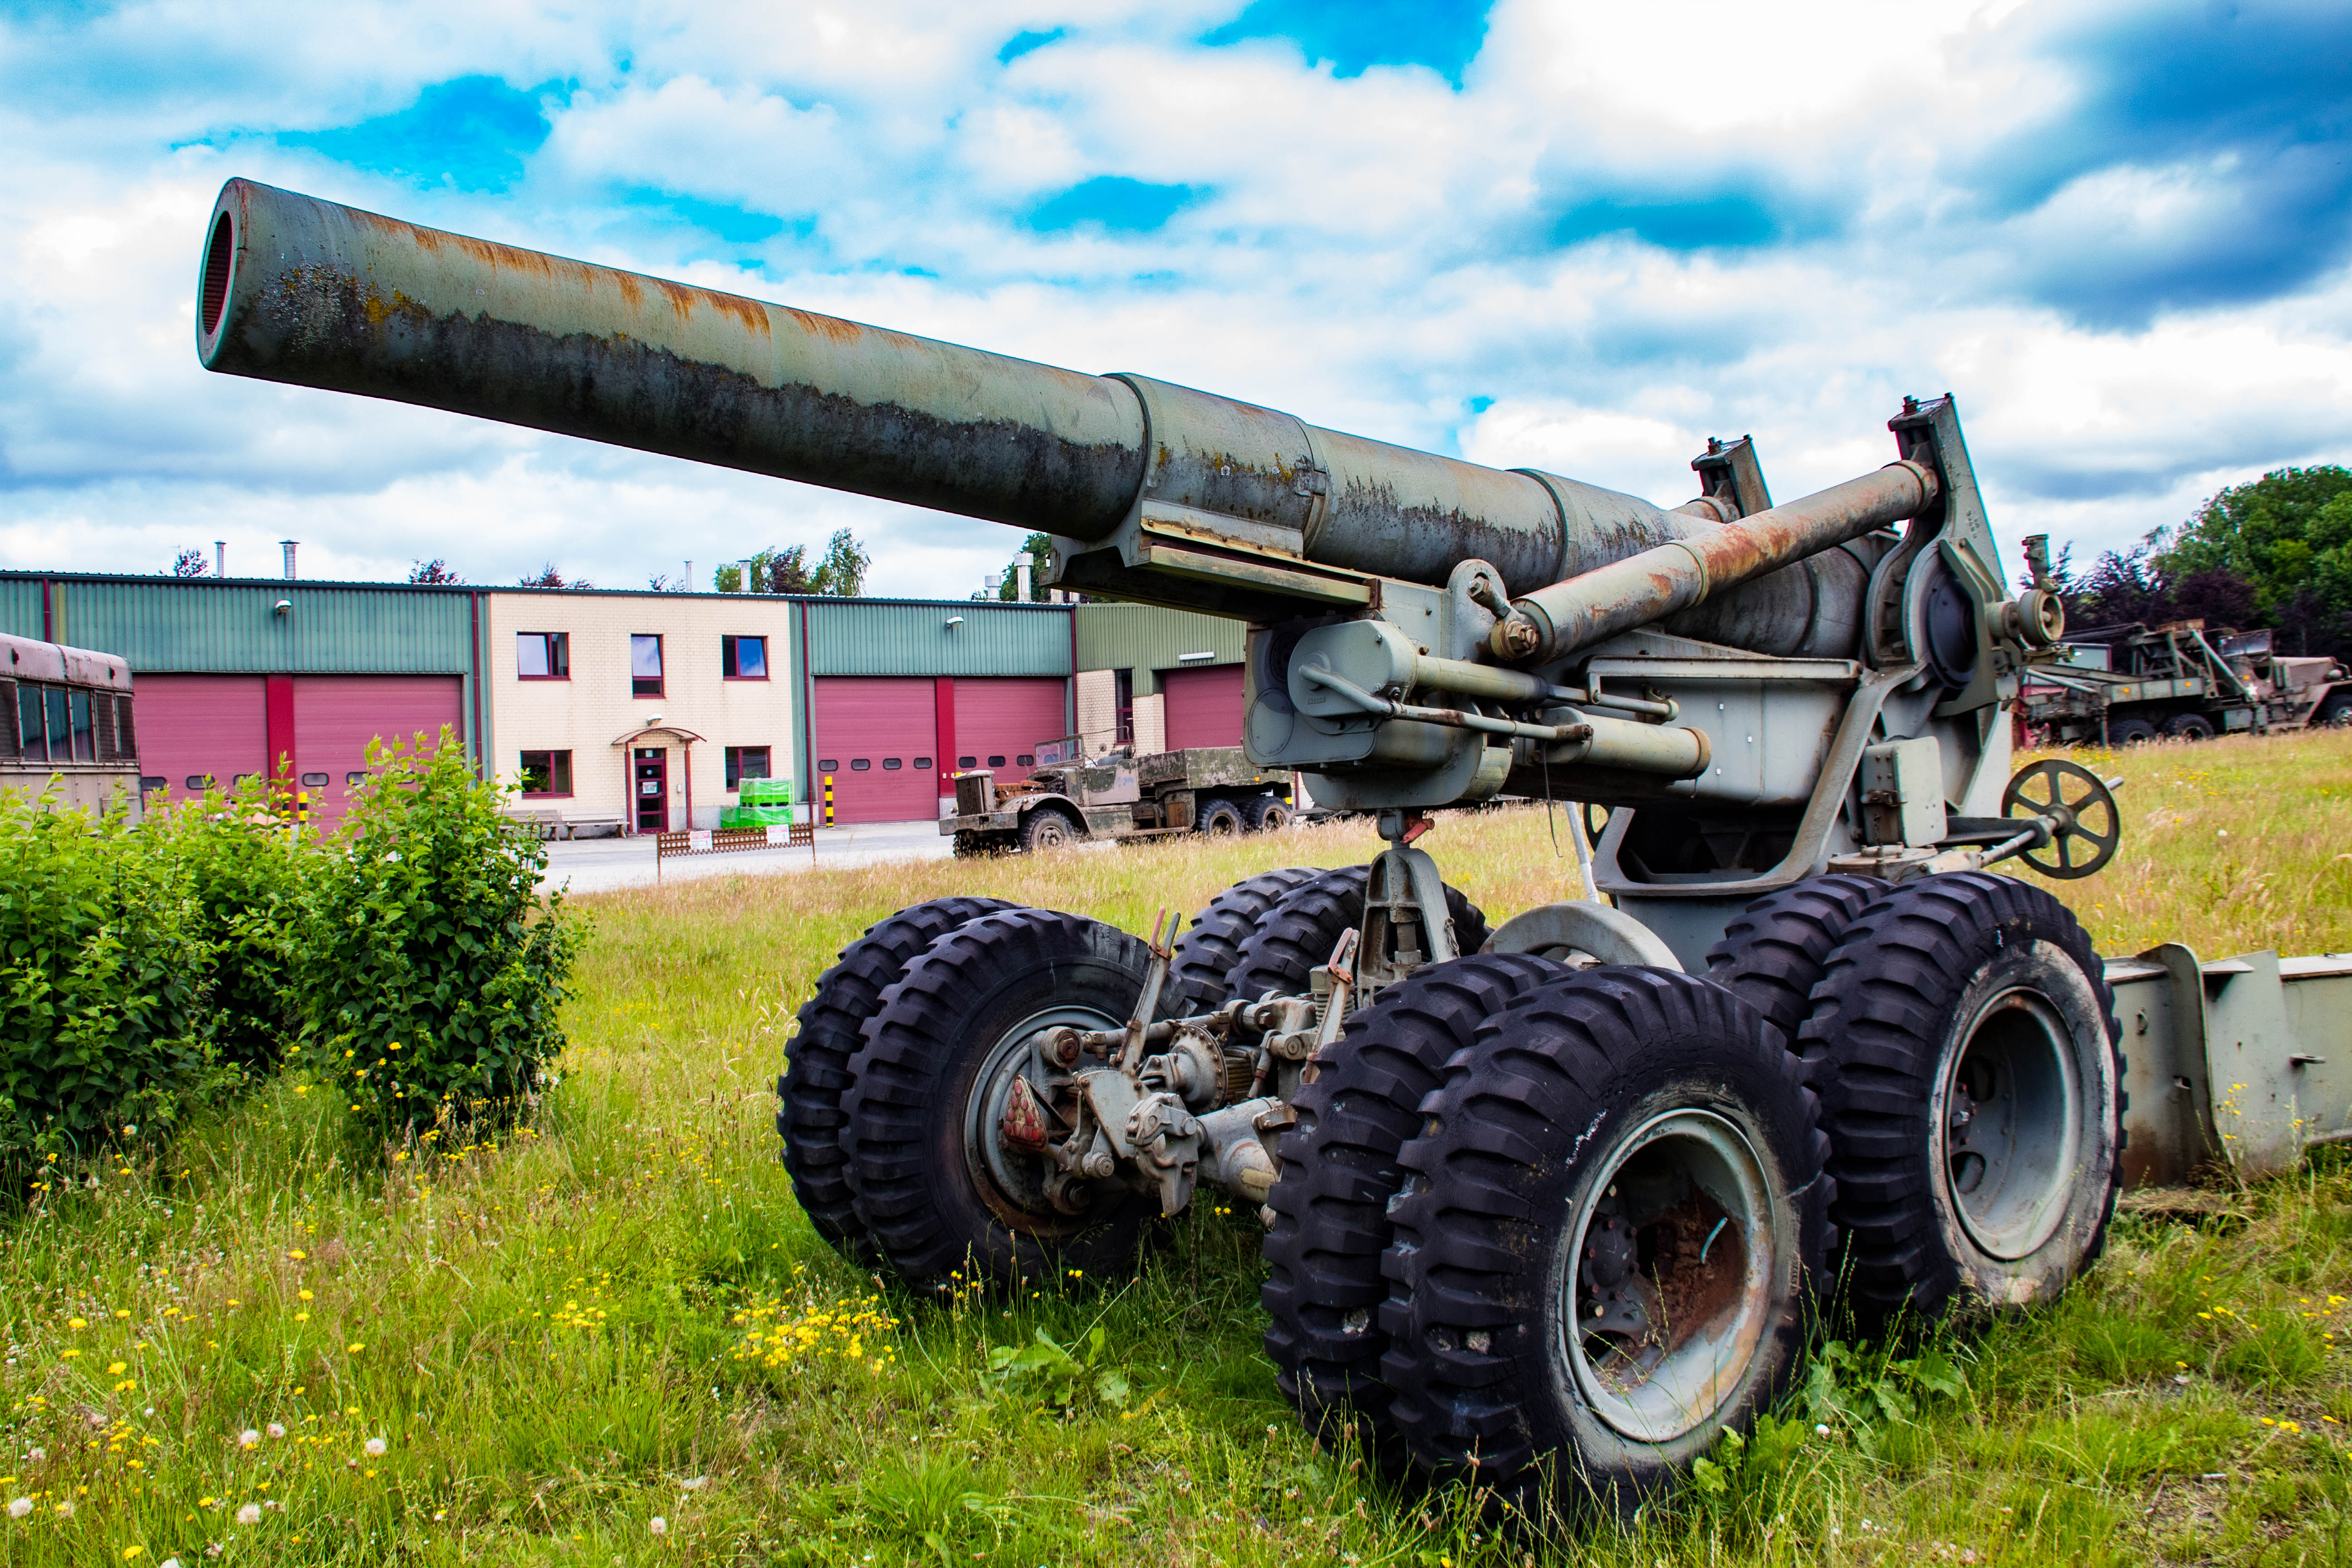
[1929,987,2082,1262]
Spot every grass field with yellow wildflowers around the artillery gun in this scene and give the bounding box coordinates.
[0,736,2352,1568]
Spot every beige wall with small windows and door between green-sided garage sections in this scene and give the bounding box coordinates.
[485,593,797,828]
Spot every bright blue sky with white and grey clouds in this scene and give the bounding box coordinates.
[0,0,2352,595]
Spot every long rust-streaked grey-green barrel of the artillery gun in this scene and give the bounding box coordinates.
[197,179,1928,621]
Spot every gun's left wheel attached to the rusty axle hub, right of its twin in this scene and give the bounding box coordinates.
[842,910,1157,1291]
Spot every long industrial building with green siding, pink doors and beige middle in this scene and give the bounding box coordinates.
[0,571,1244,832]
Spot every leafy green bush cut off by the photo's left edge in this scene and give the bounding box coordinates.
[0,790,223,1171]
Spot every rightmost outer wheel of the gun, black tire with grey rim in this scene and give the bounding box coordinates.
[1804,872,2122,1328]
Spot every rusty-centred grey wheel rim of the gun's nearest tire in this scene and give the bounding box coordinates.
[1559,1110,1780,1443]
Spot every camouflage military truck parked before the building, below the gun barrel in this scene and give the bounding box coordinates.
[938,736,1291,856]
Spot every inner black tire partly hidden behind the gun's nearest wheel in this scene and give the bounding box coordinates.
[1258,952,1567,1467]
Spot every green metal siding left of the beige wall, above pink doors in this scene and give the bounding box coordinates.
[30,578,473,675]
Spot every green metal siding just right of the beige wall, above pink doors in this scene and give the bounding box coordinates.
[802,599,1070,675]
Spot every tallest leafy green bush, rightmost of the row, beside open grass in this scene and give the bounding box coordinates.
[294,736,583,1138]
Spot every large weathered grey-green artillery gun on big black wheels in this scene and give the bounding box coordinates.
[195,181,2352,1507]
